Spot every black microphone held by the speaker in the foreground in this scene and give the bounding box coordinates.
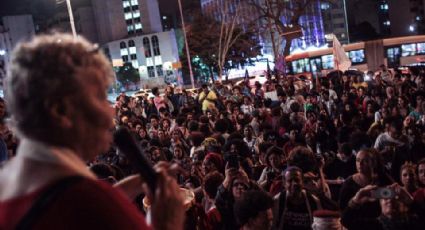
[114,127,157,193]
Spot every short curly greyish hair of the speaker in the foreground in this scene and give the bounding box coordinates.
[5,34,113,145]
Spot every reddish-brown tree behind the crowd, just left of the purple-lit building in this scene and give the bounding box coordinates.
[186,6,261,82]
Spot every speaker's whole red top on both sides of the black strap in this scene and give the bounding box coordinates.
[0,179,150,230]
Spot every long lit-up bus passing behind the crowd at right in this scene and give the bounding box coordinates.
[285,35,425,76]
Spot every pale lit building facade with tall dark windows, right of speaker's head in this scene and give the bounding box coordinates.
[104,30,179,87]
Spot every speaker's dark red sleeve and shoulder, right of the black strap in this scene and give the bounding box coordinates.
[34,180,150,230]
